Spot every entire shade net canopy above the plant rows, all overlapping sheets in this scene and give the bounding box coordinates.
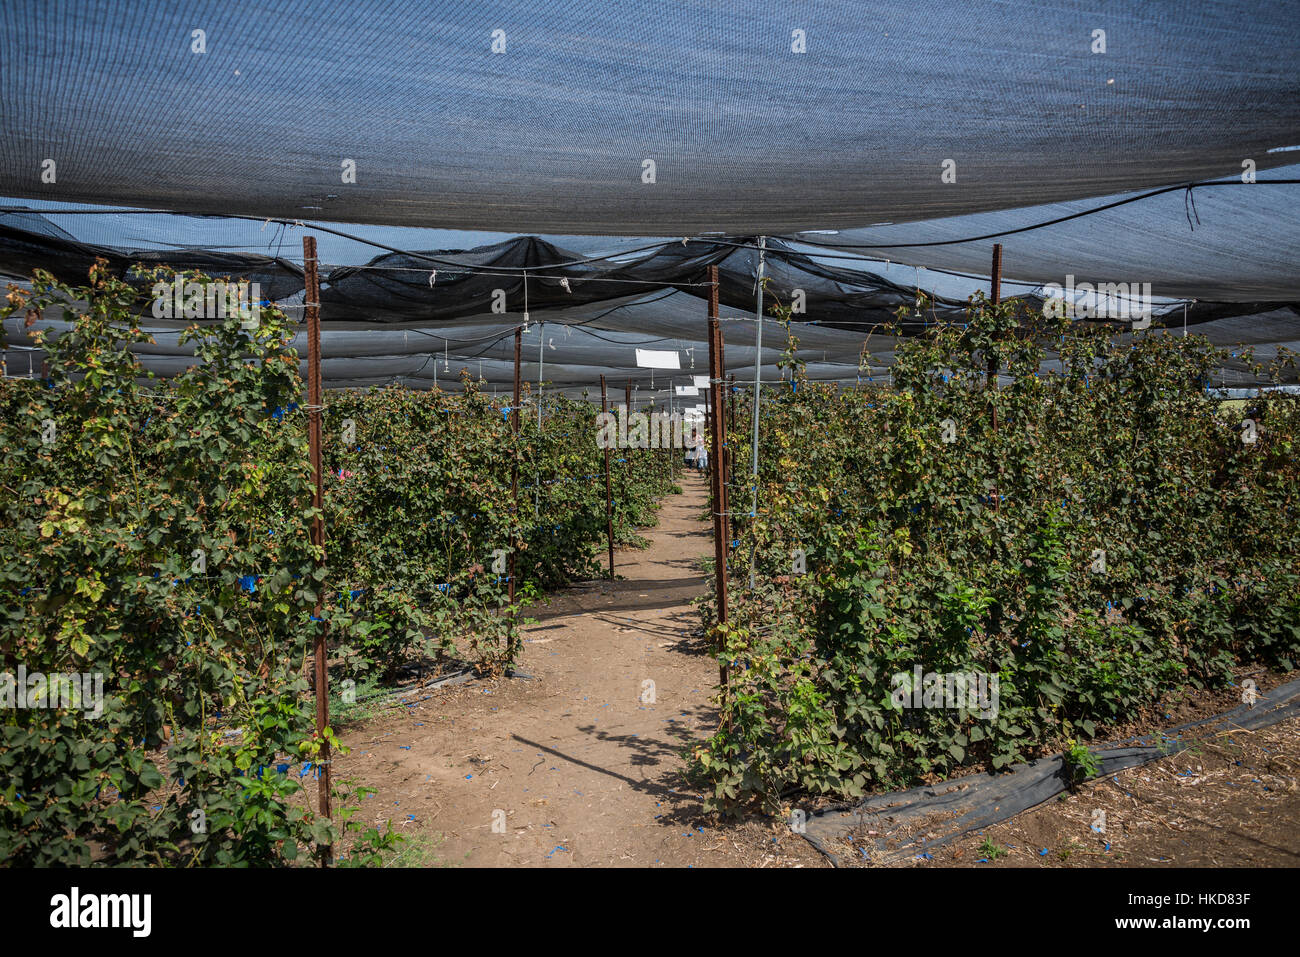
[0,0,1300,402]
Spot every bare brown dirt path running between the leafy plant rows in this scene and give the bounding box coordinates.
[338,475,818,866]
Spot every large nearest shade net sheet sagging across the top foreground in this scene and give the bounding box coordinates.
[0,0,1300,235]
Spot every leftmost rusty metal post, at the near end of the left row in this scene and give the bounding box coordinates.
[303,235,334,866]
